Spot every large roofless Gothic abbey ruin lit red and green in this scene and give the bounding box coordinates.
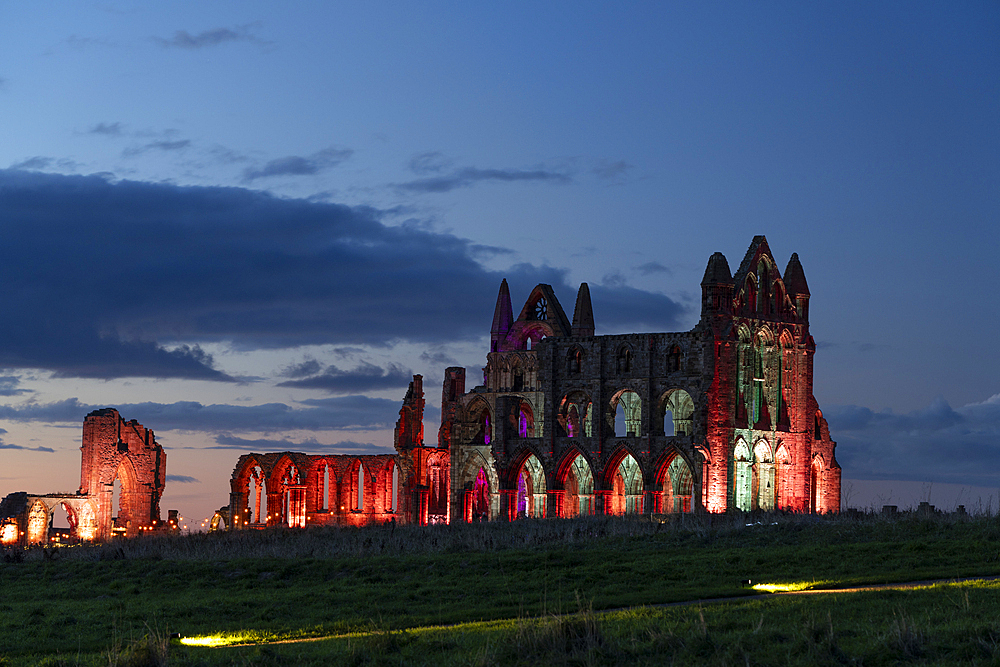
[225,236,840,528]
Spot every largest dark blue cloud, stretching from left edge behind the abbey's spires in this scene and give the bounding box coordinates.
[0,170,683,380]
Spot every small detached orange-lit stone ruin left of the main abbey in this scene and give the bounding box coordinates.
[0,408,168,545]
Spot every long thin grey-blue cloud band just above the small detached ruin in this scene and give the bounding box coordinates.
[0,396,414,433]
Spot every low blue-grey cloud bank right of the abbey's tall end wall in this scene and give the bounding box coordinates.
[824,394,1000,486]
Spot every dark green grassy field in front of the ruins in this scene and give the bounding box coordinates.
[0,515,1000,665]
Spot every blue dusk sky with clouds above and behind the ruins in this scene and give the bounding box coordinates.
[0,0,1000,527]
